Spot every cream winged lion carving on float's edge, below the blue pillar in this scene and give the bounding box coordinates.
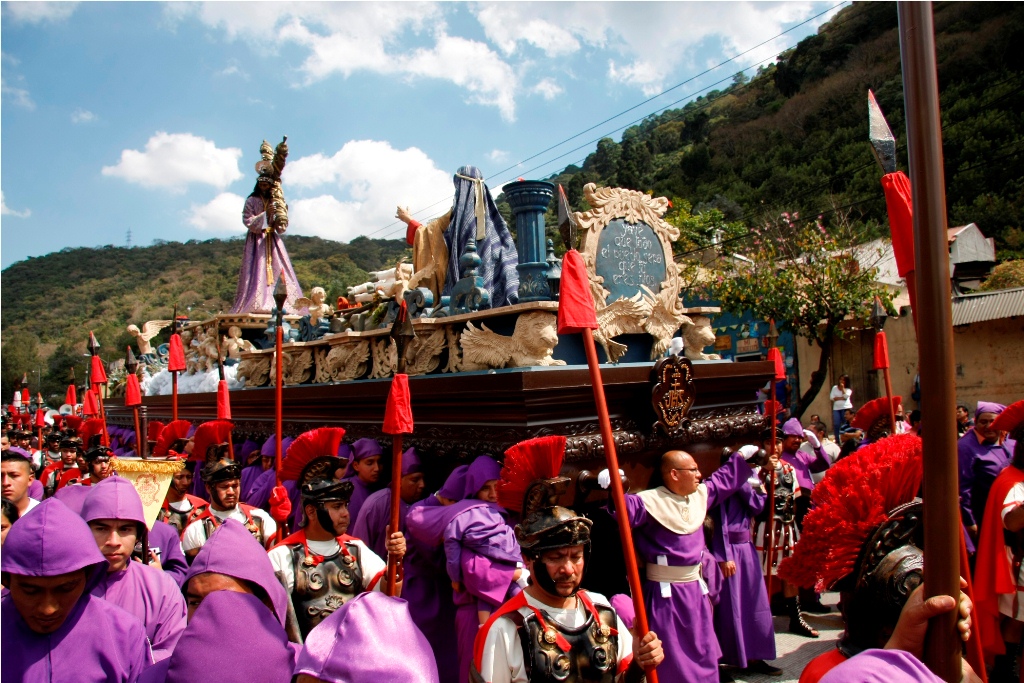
[462,312,565,371]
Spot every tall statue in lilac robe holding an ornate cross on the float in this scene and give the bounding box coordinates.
[230,137,304,315]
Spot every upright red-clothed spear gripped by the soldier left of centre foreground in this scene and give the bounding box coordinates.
[381,299,416,597]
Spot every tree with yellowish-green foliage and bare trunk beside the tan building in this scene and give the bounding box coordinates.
[690,213,892,417]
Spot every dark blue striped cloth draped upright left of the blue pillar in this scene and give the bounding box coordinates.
[441,166,519,308]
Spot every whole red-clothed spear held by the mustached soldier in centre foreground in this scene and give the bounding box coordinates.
[558,187,657,683]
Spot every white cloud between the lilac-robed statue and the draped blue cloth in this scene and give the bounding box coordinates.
[284,140,454,242]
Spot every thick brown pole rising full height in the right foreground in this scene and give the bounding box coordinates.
[897,0,961,681]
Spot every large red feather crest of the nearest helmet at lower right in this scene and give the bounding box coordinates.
[778,434,923,590]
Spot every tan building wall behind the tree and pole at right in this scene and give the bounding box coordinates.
[796,315,1024,426]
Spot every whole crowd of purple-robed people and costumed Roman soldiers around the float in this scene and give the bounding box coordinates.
[0,395,1024,683]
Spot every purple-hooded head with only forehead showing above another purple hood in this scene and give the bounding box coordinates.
[182,519,288,626]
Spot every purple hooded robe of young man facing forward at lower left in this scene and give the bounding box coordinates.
[82,476,185,660]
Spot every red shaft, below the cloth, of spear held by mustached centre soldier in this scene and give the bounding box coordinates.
[583,329,657,683]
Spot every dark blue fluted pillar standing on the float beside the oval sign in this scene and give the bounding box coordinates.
[502,180,555,302]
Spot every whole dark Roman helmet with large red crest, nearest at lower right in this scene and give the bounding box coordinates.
[778,434,924,656]
